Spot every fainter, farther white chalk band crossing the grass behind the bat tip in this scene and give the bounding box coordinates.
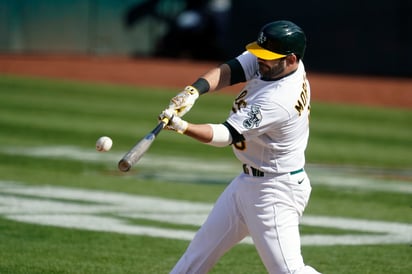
[0,146,412,194]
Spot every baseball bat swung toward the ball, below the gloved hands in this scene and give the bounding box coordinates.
[118,118,169,172]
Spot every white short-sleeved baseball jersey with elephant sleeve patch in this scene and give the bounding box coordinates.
[227,52,310,173]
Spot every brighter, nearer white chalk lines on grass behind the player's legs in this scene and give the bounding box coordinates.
[0,180,412,246]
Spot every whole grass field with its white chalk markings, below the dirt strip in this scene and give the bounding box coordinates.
[0,75,412,274]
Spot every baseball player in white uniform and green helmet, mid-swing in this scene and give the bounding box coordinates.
[159,20,319,274]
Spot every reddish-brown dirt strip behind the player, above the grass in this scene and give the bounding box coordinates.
[0,55,412,108]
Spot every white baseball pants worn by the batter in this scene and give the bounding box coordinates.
[171,171,319,274]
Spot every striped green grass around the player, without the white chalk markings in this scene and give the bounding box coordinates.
[0,75,412,274]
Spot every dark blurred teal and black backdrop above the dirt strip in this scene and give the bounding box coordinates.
[0,0,412,77]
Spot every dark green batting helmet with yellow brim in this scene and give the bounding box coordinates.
[246,20,306,60]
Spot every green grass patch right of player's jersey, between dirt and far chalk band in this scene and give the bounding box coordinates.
[308,104,412,168]
